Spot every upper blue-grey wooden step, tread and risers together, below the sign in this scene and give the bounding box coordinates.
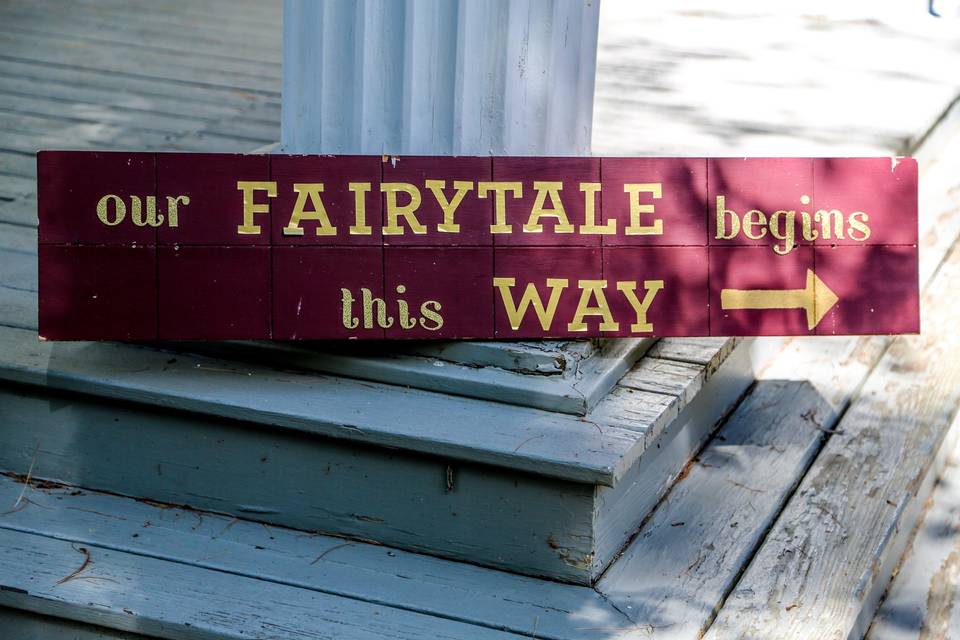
[0,330,753,583]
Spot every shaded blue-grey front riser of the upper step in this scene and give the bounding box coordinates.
[0,386,594,583]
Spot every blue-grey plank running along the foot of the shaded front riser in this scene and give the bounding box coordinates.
[0,478,629,639]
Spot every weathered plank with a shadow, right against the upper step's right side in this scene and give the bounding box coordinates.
[597,380,834,639]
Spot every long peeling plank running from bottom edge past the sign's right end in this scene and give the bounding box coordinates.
[706,242,960,640]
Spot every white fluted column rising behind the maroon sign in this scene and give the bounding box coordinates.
[281,0,600,155]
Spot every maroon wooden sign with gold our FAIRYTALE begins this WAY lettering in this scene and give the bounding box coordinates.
[37,151,919,340]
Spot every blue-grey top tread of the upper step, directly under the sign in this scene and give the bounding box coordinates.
[0,235,735,484]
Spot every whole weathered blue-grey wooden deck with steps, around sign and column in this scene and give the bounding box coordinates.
[0,0,960,640]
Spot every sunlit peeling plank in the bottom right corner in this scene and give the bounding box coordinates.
[866,424,960,640]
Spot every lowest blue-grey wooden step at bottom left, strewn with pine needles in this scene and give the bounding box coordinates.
[0,470,631,640]
